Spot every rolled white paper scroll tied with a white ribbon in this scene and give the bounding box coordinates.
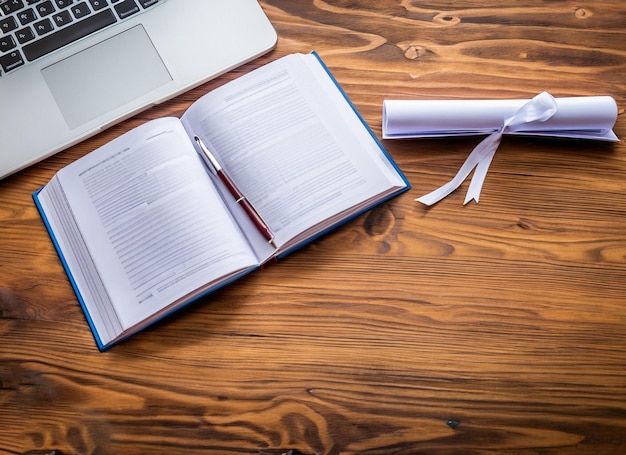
[383,92,618,205]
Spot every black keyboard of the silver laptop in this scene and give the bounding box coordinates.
[0,0,163,77]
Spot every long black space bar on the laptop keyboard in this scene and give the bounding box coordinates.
[23,9,116,61]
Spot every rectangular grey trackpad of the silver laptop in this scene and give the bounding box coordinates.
[41,25,172,129]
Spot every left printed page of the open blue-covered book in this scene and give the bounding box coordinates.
[46,118,257,329]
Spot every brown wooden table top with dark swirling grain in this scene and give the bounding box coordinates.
[0,0,626,454]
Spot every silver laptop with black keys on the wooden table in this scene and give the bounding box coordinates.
[0,0,277,178]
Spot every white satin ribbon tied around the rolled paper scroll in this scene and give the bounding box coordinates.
[415,92,557,205]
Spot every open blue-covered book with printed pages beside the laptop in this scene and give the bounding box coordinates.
[34,53,409,350]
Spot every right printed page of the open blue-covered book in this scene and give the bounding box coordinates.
[183,54,405,253]
